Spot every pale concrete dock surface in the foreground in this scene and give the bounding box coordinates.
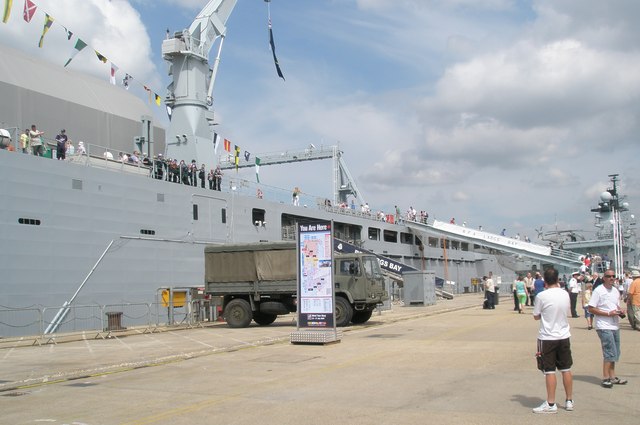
[0,294,640,425]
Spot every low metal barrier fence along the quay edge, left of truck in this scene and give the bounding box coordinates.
[0,299,219,349]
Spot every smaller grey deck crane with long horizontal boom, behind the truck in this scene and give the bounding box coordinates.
[220,144,366,205]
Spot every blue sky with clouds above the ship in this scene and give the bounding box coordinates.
[0,0,640,241]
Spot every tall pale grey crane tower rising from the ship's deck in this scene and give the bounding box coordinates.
[162,0,237,167]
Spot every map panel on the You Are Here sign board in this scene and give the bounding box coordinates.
[299,227,333,313]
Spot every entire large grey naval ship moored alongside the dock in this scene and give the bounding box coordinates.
[0,0,579,337]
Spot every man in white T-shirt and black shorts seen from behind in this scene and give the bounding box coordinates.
[533,267,573,413]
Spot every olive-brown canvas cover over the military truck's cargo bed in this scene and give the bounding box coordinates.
[204,242,296,283]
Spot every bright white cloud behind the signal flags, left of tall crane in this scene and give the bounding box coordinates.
[0,0,162,87]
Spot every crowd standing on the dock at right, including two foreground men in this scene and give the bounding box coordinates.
[483,267,640,413]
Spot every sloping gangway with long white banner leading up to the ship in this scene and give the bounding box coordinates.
[404,220,582,268]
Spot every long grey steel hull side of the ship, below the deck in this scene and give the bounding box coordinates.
[0,151,510,322]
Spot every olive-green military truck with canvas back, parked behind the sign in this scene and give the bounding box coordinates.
[204,242,389,328]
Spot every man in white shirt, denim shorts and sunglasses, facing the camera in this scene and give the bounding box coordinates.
[589,269,627,388]
